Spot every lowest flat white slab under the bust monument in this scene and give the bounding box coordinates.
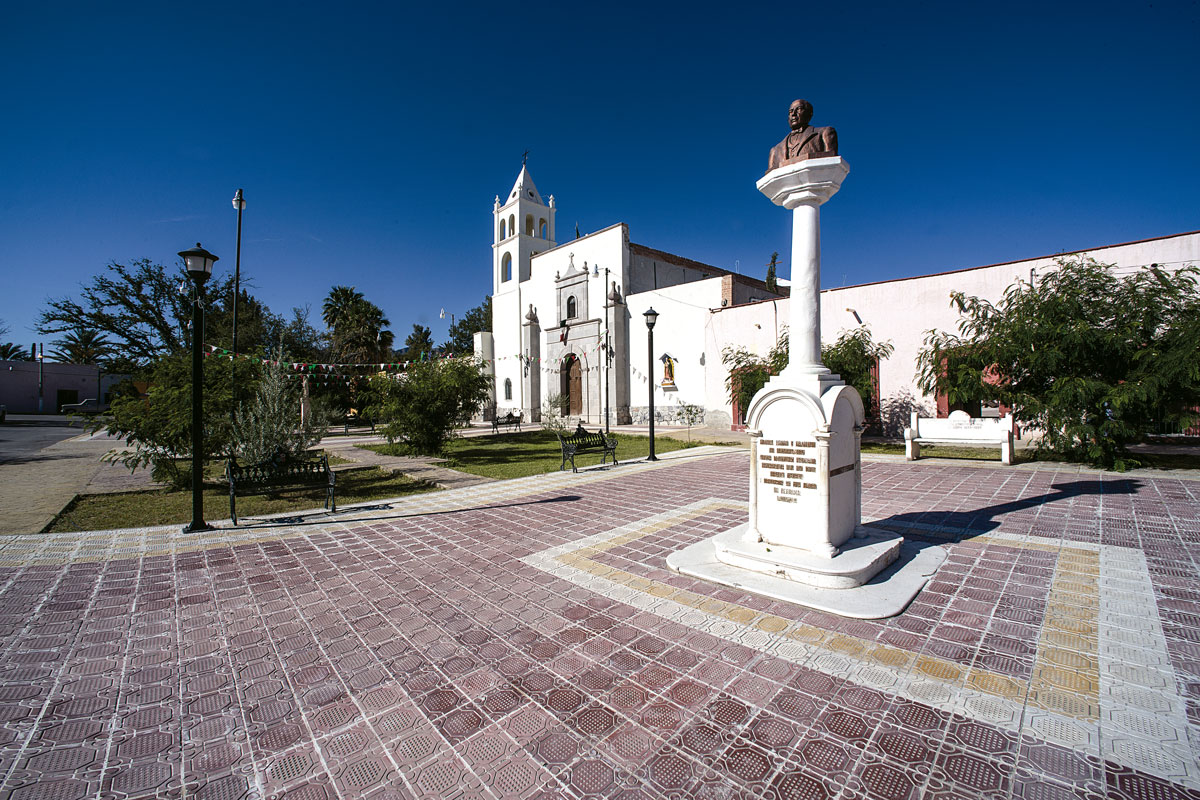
[667,525,946,619]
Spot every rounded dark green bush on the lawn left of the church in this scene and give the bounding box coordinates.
[367,359,490,456]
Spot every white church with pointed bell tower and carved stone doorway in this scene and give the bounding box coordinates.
[475,167,781,425]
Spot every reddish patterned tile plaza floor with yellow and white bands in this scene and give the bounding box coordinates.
[0,449,1200,800]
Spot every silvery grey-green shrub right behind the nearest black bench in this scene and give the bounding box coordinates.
[233,355,328,463]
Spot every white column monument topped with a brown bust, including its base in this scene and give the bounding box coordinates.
[667,101,946,619]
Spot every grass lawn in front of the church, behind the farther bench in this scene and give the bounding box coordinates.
[368,431,703,479]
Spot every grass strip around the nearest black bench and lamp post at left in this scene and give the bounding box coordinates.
[46,468,437,533]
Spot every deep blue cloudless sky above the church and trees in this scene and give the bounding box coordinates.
[0,1,1200,344]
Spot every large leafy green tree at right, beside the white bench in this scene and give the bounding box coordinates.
[917,257,1200,470]
